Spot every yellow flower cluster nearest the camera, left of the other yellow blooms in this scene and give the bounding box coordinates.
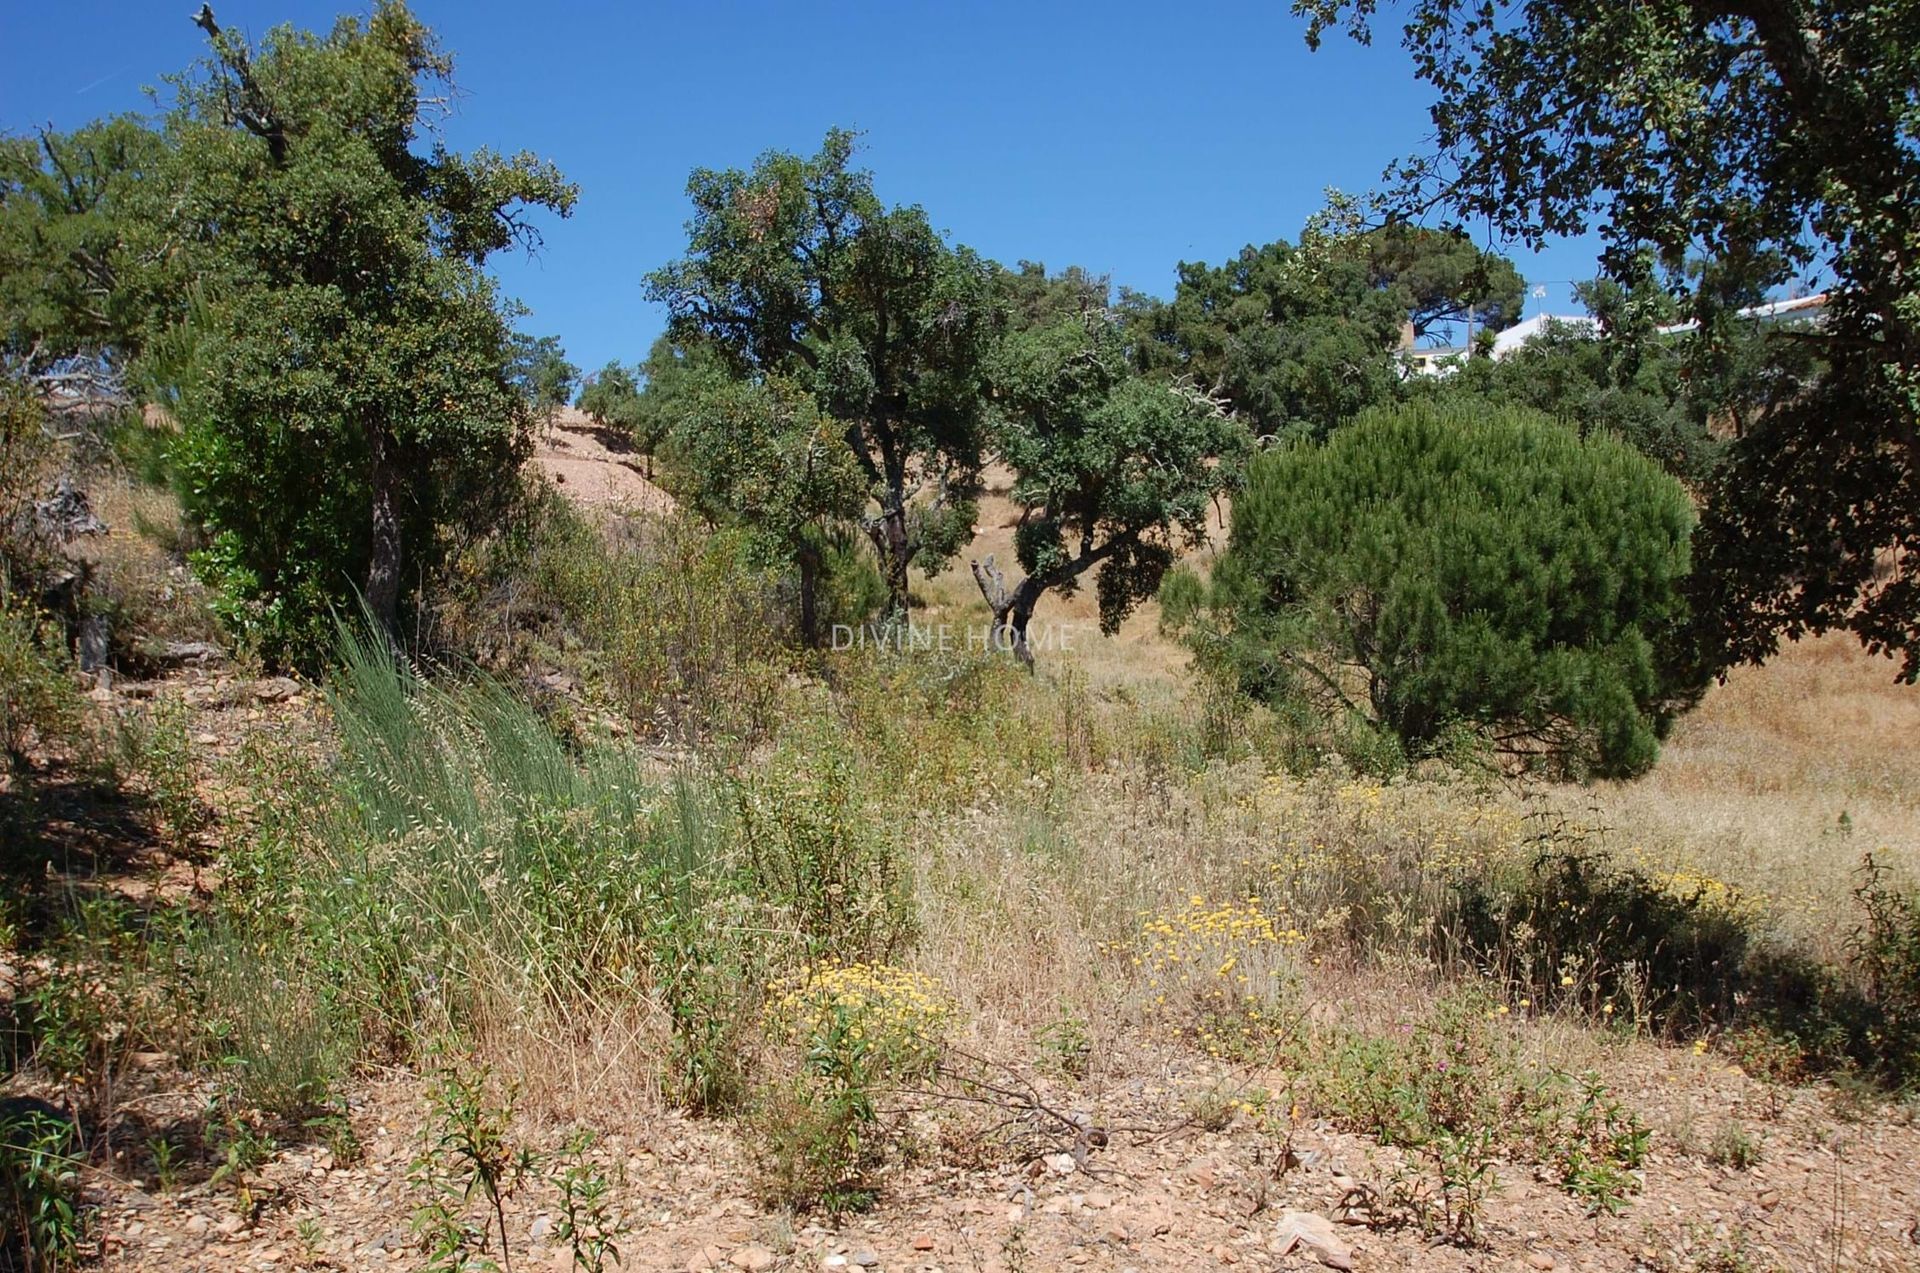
[768,964,954,1069]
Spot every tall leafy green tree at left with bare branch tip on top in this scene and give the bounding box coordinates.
[152,2,574,653]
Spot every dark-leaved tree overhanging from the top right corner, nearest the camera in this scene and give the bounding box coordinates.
[1294,0,1920,682]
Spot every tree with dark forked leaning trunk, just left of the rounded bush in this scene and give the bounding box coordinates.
[972,263,1246,666]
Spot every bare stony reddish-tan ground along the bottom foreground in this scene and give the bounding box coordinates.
[86,1056,1920,1273]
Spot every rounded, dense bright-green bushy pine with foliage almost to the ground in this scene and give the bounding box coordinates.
[1173,401,1695,776]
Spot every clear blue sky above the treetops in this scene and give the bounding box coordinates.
[0,0,1596,369]
